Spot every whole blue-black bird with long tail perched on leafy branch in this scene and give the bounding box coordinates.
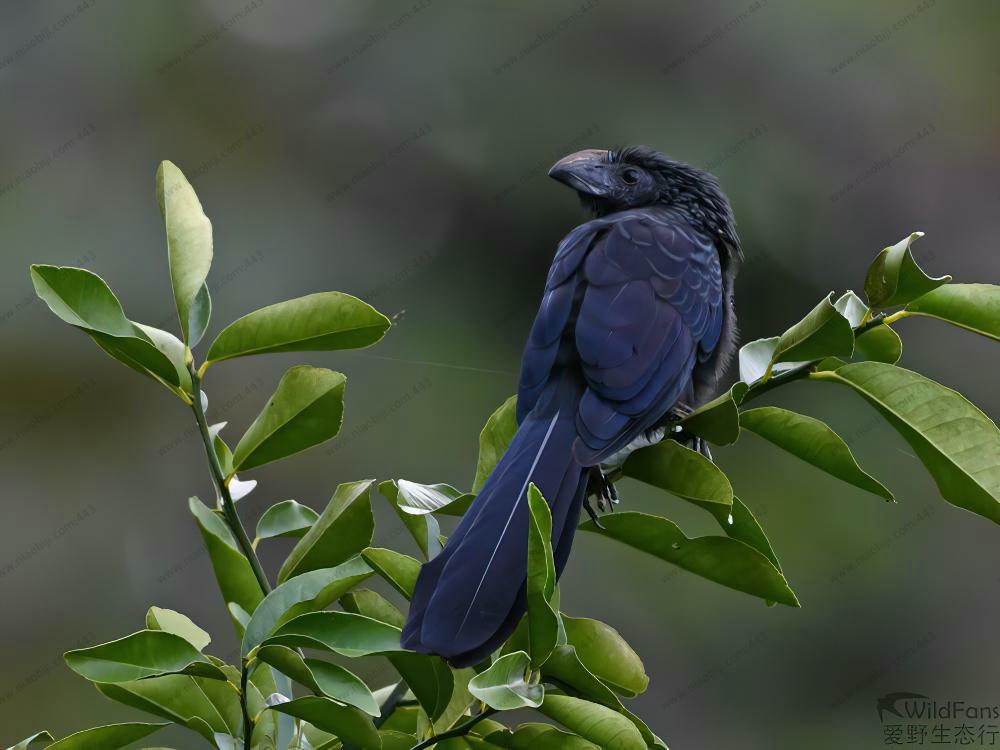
[401,146,743,668]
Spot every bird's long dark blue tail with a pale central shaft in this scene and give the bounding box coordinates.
[403,378,588,666]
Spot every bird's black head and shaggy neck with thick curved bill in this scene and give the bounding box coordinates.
[549,146,740,264]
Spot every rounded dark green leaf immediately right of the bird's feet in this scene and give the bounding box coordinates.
[622,440,733,506]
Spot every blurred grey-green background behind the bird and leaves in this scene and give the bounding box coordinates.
[0,0,1000,750]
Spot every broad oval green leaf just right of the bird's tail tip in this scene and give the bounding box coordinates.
[563,615,649,698]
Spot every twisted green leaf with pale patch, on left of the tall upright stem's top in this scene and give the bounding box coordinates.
[31,265,191,392]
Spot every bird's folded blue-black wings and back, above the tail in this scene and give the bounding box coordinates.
[518,211,723,465]
